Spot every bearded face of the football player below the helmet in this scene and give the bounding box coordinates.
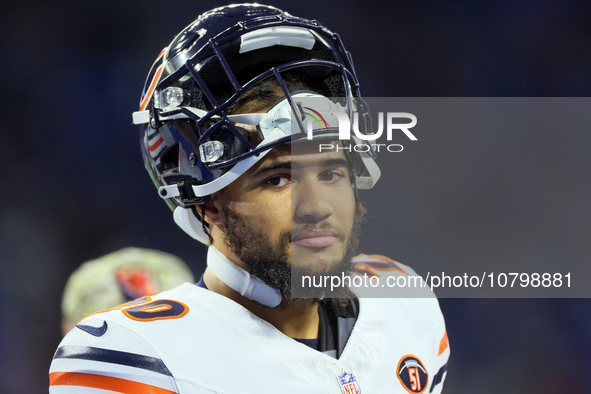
[220,144,356,298]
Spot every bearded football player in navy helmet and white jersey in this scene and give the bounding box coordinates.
[50,4,449,394]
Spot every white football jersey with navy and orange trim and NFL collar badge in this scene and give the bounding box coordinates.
[49,255,449,394]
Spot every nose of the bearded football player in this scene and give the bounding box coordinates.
[291,180,334,223]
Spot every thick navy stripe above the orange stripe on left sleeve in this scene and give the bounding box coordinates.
[53,346,172,376]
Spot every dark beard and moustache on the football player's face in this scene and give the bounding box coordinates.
[220,204,361,303]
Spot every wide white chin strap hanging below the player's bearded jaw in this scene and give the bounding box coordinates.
[207,245,281,308]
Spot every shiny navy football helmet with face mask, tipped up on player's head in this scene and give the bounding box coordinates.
[133,4,380,244]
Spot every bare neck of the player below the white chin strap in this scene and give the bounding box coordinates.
[203,269,320,339]
